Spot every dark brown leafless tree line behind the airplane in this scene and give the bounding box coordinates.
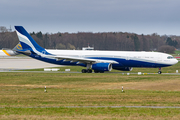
[0,27,180,53]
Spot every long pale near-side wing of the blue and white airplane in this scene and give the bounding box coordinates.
[41,55,118,64]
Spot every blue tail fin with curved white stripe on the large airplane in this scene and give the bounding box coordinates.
[15,26,45,53]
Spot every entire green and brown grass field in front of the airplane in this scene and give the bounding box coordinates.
[0,63,180,119]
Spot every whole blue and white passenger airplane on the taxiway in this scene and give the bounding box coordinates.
[2,26,178,74]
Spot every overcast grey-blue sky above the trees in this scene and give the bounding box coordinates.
[0,0,180,36]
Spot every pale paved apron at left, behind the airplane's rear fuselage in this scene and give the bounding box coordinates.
[0,57,60,71]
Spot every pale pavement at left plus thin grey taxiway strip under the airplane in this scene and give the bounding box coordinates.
[0,56,180,75]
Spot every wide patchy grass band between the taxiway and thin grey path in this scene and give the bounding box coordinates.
[0,73,180,107]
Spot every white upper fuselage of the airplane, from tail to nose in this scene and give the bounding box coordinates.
[47,49,178,66]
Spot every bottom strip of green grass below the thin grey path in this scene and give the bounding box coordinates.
[0,107,180,120]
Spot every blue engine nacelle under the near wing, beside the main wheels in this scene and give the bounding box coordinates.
[92,63,112,71]
